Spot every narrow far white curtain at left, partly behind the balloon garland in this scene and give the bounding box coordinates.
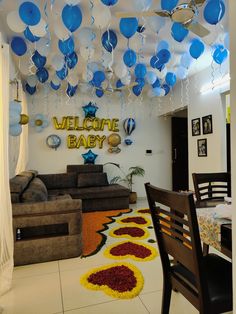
[15,82,29,174]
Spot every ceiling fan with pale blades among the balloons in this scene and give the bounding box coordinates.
[116,0,210,37]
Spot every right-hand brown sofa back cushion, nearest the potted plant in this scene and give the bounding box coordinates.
[77,173,108,188]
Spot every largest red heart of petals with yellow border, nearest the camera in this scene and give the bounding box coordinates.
[80,263,144,299]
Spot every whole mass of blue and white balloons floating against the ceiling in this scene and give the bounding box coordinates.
[7,0,229,97]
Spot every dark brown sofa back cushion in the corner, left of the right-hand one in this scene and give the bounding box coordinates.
[38,173,77,190]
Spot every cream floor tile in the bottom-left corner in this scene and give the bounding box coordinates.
[0,273,63,314]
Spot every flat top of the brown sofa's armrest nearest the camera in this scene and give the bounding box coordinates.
[12,198,82,217]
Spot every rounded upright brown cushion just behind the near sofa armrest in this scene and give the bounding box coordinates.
[21,178,48,203]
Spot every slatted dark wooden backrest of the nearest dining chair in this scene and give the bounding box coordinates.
[145,183,209,308]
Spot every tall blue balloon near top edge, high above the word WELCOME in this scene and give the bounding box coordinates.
[62,4,82,33]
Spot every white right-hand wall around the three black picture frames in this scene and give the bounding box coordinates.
[159,62,229,189]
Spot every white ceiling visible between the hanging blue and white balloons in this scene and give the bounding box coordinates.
[0,0,228,96]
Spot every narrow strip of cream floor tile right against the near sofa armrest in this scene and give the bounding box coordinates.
[13,261,58,279]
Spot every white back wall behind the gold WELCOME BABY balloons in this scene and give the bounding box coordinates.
[28,88,171,197]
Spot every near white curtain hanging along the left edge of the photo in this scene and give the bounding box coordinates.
[0,37,14,295]
